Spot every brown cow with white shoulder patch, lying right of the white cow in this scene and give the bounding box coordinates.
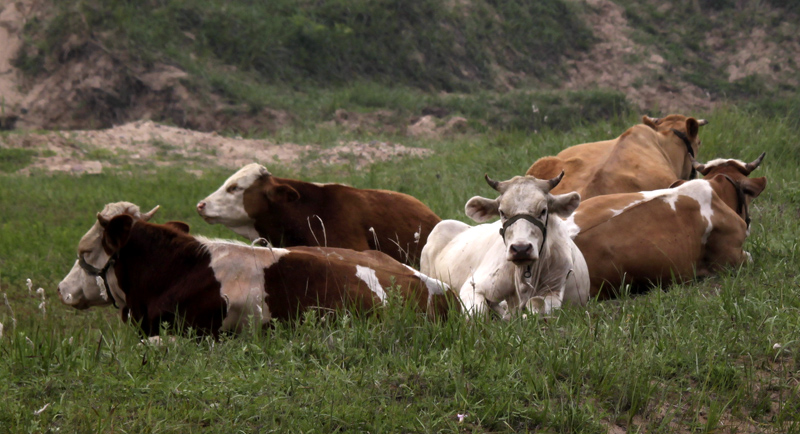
[567,154,767,298]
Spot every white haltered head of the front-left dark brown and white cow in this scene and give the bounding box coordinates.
[58,202,159,309]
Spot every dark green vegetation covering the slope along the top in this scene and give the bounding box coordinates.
[18,0,592,91]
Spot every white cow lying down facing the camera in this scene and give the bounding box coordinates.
[420,172,589,315]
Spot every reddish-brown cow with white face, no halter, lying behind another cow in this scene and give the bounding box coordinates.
[197,163,441,264]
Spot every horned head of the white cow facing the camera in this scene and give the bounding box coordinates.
[465,172,581,265]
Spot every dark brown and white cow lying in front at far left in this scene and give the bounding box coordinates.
[58,203,458,336]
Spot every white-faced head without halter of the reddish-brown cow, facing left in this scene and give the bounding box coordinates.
[197,163,300,240]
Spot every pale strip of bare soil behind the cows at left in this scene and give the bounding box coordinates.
[0,121,433,174]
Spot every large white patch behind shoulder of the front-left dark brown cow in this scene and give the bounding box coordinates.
[197,237,290,331]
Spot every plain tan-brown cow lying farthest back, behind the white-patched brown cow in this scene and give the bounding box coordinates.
[526,115,708,200]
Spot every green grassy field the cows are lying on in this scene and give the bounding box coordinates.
[0,105,800,433]
